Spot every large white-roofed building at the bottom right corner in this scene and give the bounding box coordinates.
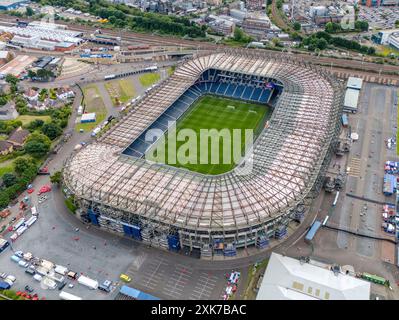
[256,252,370,300]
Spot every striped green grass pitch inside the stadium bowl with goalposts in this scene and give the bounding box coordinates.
[146,95,271,175]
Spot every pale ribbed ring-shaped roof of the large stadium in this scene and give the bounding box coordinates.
[64,50,342,232]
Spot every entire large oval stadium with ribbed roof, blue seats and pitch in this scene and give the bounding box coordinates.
[63,50,343,257]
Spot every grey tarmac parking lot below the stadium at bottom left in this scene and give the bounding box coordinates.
[0,184,244,300]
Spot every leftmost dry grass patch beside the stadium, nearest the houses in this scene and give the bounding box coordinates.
[75,85,107,131]
